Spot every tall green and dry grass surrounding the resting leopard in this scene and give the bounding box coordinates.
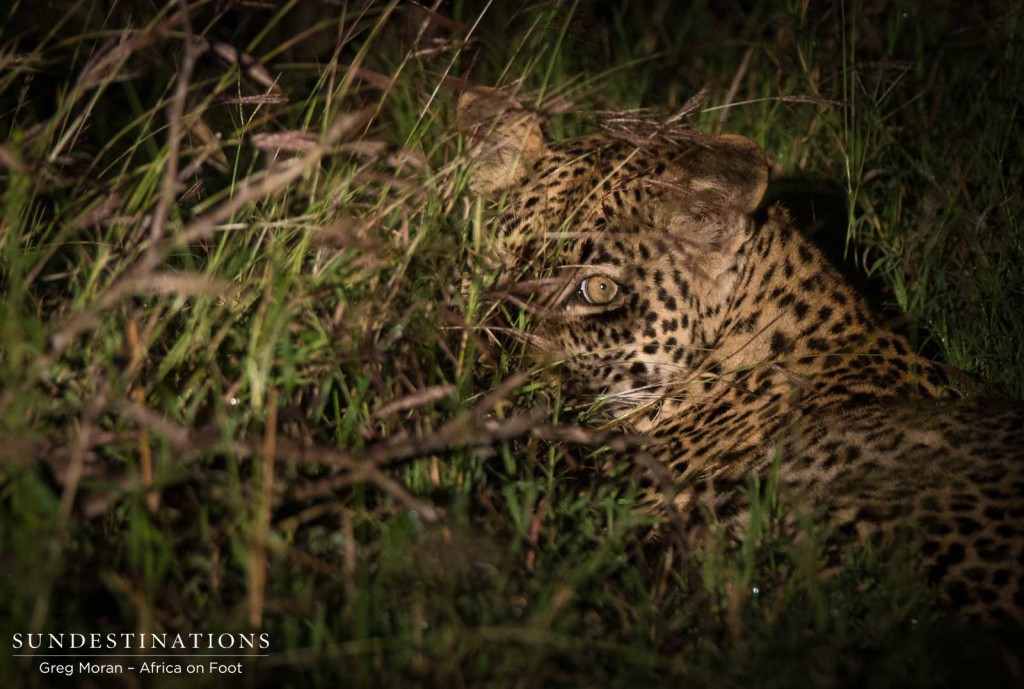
[0,0,1024,687]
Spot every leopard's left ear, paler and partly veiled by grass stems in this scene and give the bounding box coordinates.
[456,87,547,193]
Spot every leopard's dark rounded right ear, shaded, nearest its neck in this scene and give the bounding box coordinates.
[673,134,768,216]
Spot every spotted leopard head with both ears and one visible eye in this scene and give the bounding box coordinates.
[458,85,767,406]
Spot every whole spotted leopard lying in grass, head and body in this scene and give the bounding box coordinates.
[456,87,1024,629]
